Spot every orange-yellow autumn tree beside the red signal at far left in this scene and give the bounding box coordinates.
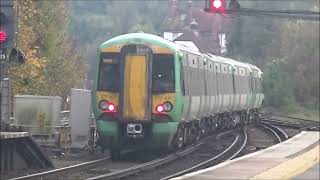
[9,0,47,94]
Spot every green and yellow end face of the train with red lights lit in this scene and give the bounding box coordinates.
[93,33,181,153]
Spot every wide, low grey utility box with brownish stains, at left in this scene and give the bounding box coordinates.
[14,95,61,136]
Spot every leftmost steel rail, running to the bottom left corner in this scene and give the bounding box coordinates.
[9,157,110,180]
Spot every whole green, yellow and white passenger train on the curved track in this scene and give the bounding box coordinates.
[92,32,264,159]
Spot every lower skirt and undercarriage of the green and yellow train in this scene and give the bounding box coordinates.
[97,109,259,159]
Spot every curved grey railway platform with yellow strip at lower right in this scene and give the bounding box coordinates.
[173,131,320,180]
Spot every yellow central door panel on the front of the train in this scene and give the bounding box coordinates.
[123,55,147,120]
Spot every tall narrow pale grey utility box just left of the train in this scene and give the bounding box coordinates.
[70,89,92,148]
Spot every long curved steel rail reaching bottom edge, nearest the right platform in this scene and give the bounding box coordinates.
[161,128,248,180]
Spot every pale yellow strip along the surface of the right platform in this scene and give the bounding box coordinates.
[250,145,320,179]
